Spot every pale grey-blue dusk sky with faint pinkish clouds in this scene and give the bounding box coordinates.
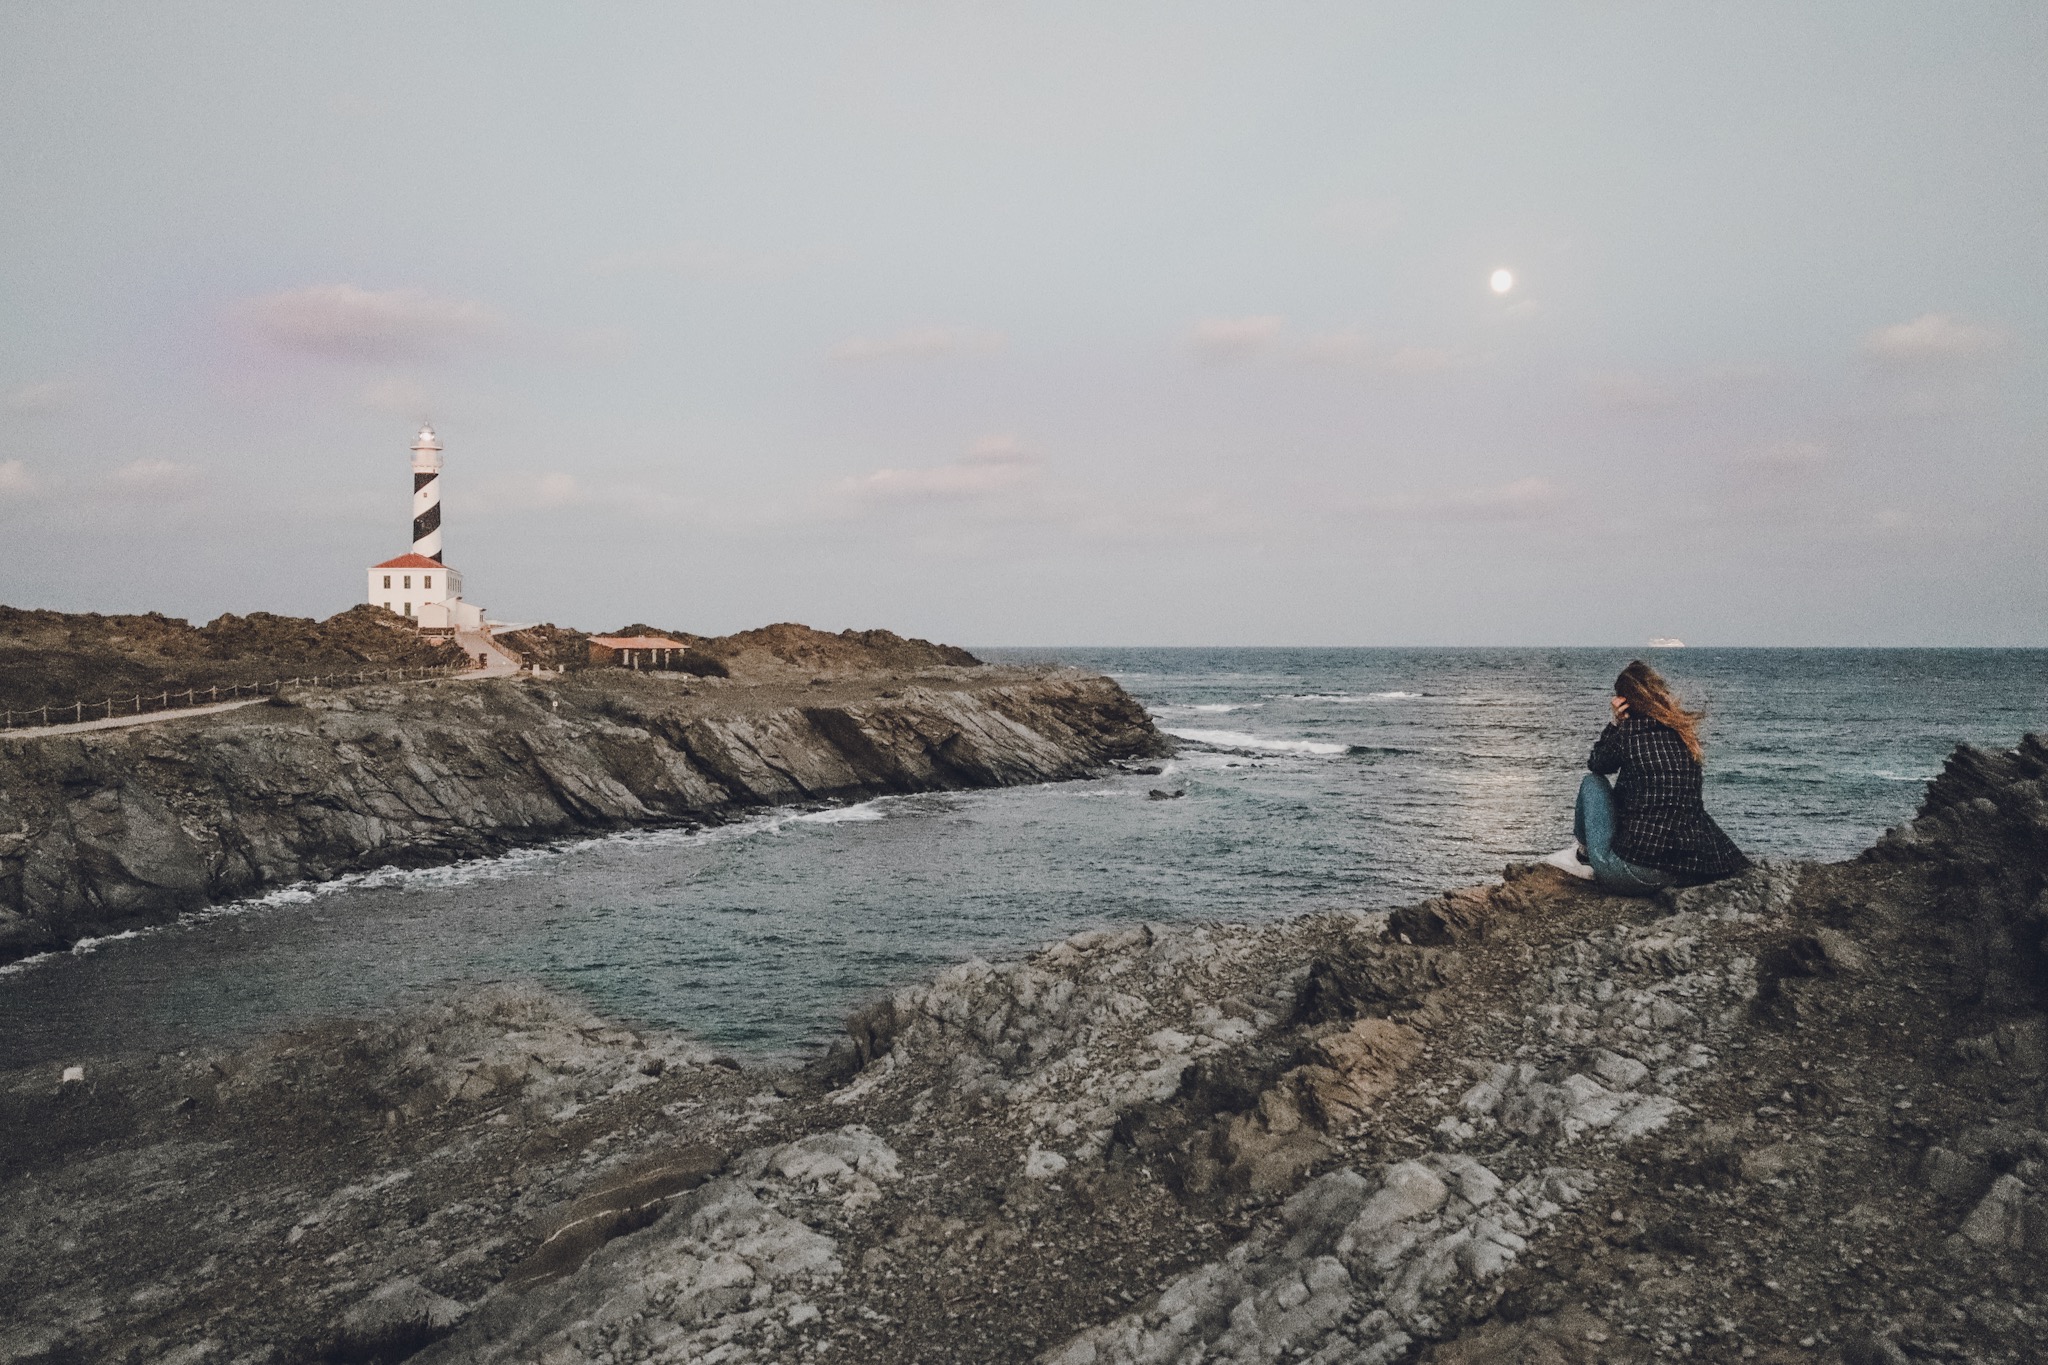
[0,0,2048,647]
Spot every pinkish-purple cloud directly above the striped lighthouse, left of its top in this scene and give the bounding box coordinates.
[233,284,504,360]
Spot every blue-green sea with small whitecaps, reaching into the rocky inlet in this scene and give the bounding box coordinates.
[0,649,2048,1066]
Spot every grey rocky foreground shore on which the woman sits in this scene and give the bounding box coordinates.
[0,736,2048,1365]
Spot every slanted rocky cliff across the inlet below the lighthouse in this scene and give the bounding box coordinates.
[0,667,1163,956]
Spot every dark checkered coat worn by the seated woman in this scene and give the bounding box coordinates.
[1585,716,1749,886]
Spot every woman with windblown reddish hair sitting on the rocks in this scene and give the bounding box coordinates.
[1573,659,1749,896]
